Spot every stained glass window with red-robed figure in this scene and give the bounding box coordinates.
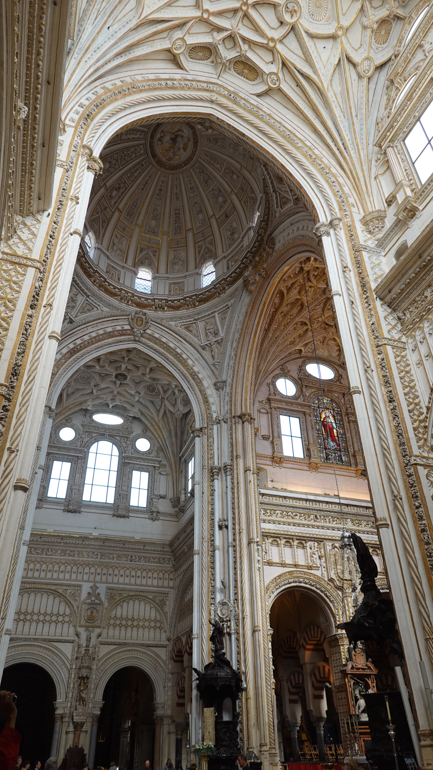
[313,396,350,465]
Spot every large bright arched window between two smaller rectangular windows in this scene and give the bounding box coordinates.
[83,441,119,503]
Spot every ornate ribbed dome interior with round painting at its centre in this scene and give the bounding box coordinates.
[87,120,265,296]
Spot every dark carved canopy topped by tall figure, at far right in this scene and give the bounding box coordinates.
[339,534,403,660]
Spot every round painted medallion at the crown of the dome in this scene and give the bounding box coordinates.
[149,123,198,171]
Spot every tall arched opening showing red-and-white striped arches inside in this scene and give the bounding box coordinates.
[270,588,342,761]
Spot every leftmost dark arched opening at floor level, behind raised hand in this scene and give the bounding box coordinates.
[0,663,57,767]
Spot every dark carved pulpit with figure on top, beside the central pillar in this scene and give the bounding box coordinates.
[194,620,242,770]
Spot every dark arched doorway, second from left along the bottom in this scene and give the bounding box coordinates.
[94,666,155,770]
